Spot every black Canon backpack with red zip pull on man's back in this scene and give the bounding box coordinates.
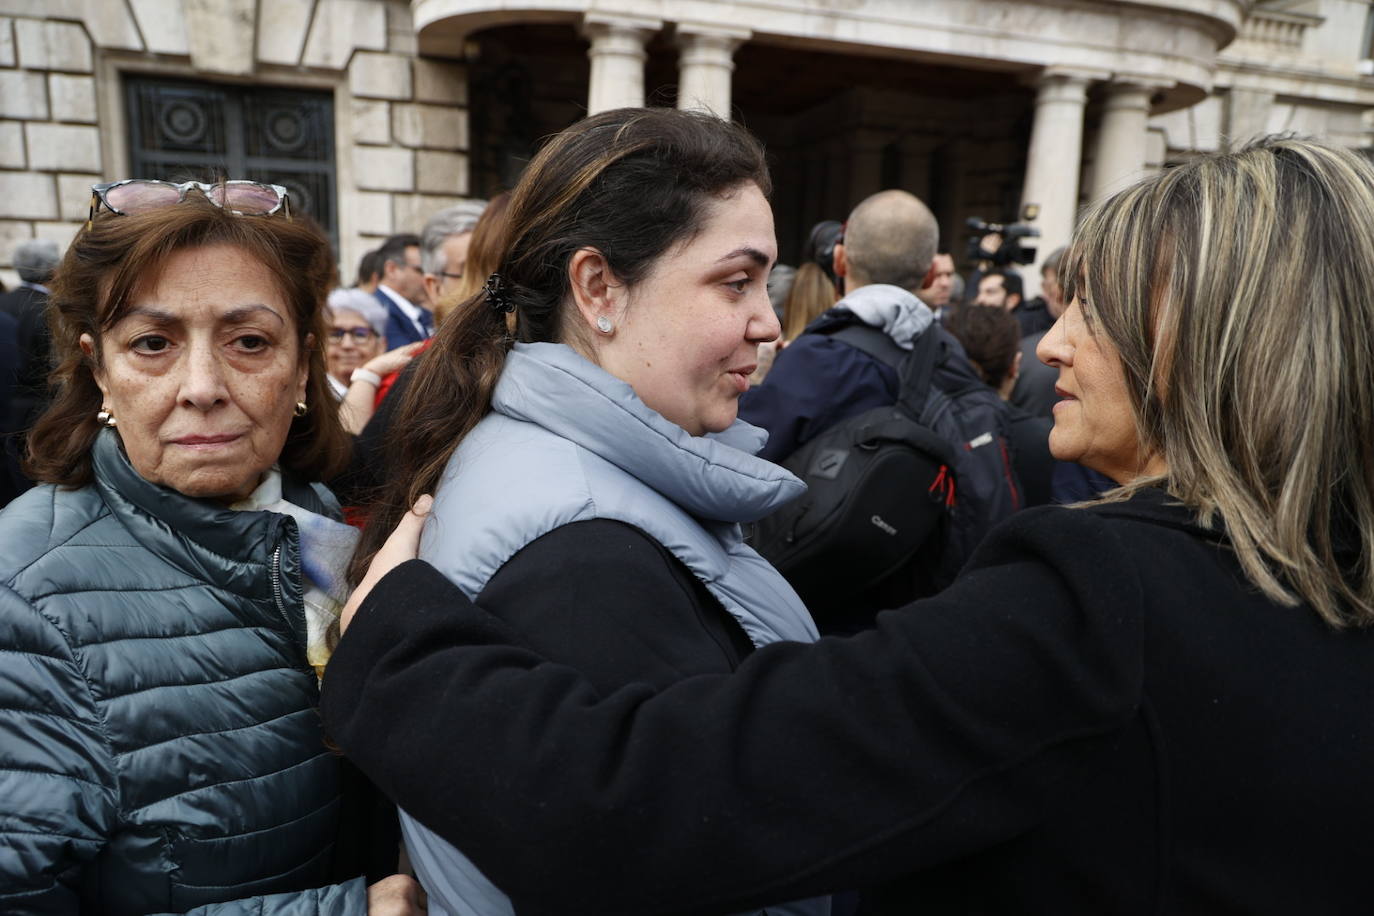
[753,325,959,612]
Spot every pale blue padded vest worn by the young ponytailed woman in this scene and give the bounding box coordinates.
[401,343,829,916]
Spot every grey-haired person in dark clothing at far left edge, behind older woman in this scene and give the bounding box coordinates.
[0,239,60,502]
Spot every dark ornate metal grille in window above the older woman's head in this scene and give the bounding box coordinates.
[125,77,338,244]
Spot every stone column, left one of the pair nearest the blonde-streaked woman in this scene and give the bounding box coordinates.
[1021,67,1107,297]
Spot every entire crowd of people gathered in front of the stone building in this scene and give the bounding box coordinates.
[0,108,1374,916]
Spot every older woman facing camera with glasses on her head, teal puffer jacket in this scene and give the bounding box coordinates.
[0,181,418,916]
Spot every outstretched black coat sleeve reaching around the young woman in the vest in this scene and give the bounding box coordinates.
[323,508,1143,915]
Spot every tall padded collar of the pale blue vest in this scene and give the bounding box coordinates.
[492,343,805,523]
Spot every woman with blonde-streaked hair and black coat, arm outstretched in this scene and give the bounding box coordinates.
[322,139,1374,916]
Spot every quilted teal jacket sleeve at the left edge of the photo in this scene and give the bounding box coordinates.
[0,586,117,913]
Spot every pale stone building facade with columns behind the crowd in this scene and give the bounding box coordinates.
[0,0,1374,293]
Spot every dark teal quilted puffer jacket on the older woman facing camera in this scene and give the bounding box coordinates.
[0,430,367,916]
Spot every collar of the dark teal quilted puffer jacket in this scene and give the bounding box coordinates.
[91,430,313,645]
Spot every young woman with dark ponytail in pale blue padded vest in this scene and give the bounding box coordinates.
[346,108,829,915]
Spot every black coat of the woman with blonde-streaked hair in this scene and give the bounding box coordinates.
[322,492,1374,916]
